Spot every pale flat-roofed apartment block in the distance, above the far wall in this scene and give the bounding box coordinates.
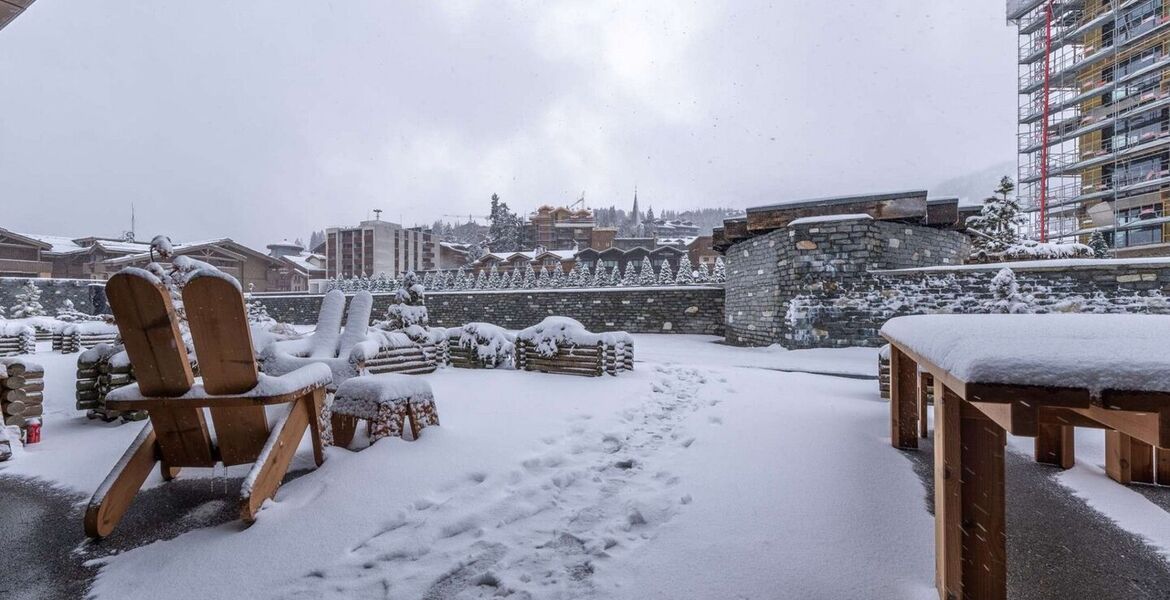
[325,220,436,280]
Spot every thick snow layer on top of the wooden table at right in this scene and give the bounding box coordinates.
[881,315,1170,394]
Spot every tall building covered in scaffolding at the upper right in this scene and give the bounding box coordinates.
[1007,0,1170,256]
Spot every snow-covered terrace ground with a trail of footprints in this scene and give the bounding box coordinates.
[0,336,1170,600]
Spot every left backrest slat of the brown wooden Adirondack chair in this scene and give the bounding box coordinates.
[105,271,194,398]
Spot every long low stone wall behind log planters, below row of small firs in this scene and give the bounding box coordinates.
[254,285,724,336]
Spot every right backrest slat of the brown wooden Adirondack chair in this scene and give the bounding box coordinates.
[183,273,260,395]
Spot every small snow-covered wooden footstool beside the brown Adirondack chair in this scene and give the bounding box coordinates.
[331,373,439,448]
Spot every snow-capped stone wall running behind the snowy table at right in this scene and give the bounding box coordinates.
[780,258,1170,347]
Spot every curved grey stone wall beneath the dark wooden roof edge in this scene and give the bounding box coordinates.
[727,218,970,345]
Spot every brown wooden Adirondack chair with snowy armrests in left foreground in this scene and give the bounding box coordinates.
[85,270,330,538]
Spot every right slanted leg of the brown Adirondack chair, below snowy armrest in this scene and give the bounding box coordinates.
[240,396,312,523]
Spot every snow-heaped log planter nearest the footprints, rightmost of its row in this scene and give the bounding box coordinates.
[516,317,634,377]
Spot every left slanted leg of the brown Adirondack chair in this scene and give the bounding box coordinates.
[85,423,159,538]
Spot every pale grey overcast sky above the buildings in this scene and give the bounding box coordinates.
[0,0,1016,247]
